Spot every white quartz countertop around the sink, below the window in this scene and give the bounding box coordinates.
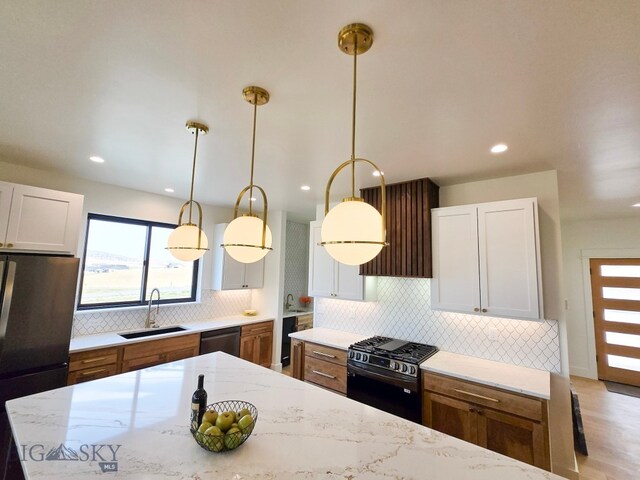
[69,315,273,353]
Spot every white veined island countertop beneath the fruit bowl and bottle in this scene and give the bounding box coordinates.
[7,352,560,480]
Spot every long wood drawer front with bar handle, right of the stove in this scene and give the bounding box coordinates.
[422,372,543,422]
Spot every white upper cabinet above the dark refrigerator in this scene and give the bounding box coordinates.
[0,182,84,255]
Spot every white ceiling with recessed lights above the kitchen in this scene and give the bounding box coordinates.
[0,0,640,218]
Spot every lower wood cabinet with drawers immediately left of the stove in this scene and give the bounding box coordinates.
[291,339,347,395]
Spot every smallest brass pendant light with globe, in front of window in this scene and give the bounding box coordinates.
[167,122,209,262]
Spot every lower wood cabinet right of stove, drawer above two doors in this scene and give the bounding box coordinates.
[422,372,551,470]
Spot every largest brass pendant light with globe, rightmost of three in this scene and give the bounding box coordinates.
[320,23,388,265]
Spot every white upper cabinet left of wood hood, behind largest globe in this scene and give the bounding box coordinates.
[309,222,377,301]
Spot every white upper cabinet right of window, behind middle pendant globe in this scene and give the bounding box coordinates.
[211,223,264,290]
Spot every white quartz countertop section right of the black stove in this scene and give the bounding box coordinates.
[420,351,551,400]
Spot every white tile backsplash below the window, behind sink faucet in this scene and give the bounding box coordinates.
[72,290,251,337]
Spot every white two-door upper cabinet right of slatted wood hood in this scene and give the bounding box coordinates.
[431,198,543,319]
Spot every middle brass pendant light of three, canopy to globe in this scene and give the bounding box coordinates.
[222,87,273,263]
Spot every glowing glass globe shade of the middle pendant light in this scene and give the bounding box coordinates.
[222,216,272,263]
